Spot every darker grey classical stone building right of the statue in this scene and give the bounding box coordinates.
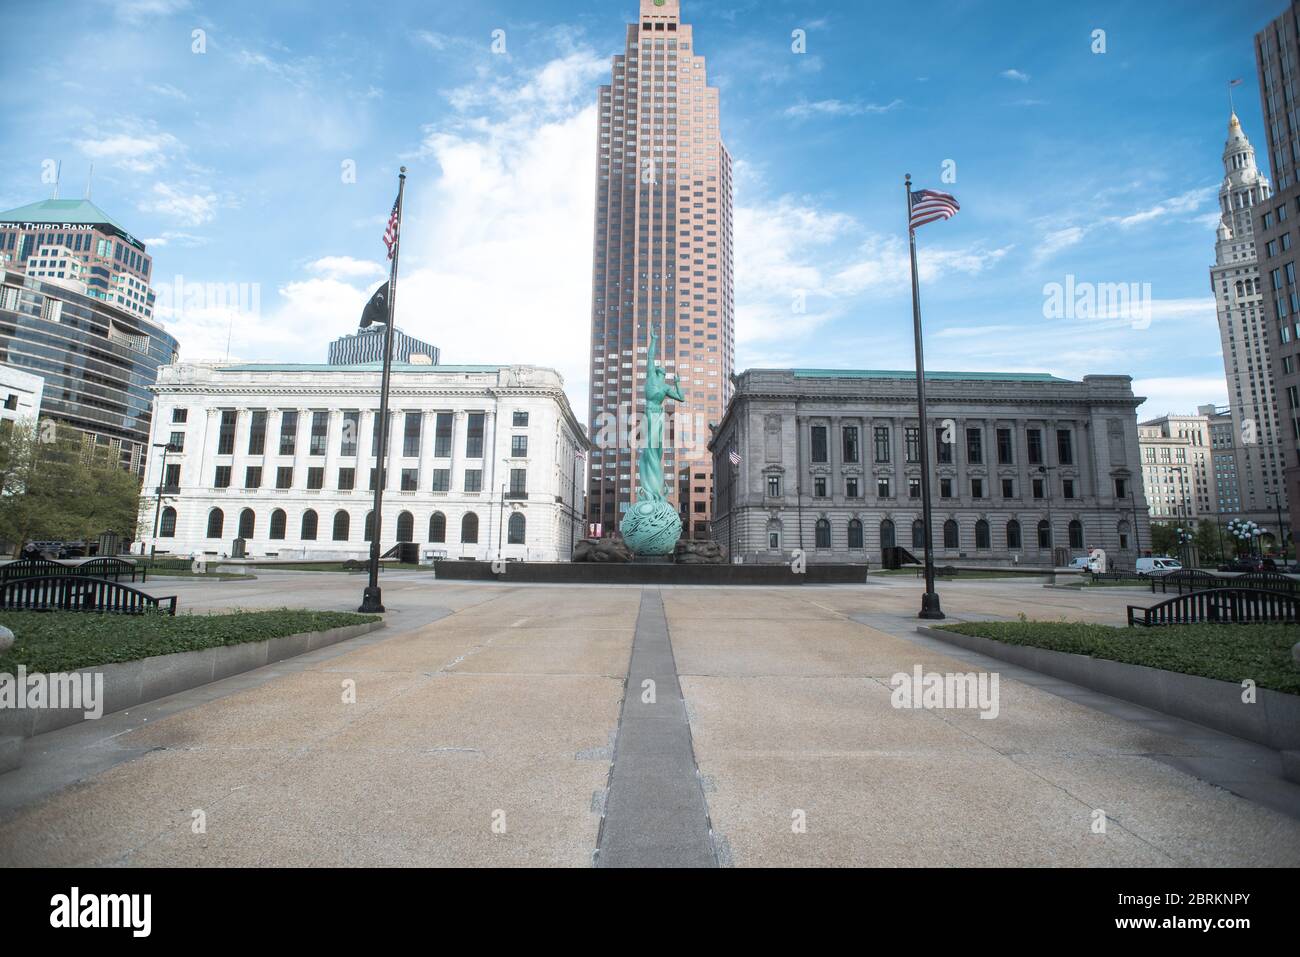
[710,369,1151,568]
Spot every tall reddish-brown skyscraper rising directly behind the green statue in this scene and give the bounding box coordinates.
[588,0,735,538]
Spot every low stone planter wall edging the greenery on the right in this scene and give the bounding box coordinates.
[917,625,1300,752]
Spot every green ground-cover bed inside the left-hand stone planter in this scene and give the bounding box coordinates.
[0,609,380,674]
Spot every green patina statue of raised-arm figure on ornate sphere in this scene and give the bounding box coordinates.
[621,322,686,555]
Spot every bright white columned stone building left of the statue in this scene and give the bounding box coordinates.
[143,363,588,562]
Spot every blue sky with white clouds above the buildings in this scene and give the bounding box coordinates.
[0,0,1284,420]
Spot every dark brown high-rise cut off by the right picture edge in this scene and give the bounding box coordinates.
[1251,3,1300,554]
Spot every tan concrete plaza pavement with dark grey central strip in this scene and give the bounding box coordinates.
[0,572,1300,866]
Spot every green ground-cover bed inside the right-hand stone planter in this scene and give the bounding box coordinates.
[943,622,1300,694]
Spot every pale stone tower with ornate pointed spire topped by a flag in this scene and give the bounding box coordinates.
[1210,113,1286,527]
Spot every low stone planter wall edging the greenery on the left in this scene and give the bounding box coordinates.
[0,622,384,748]
